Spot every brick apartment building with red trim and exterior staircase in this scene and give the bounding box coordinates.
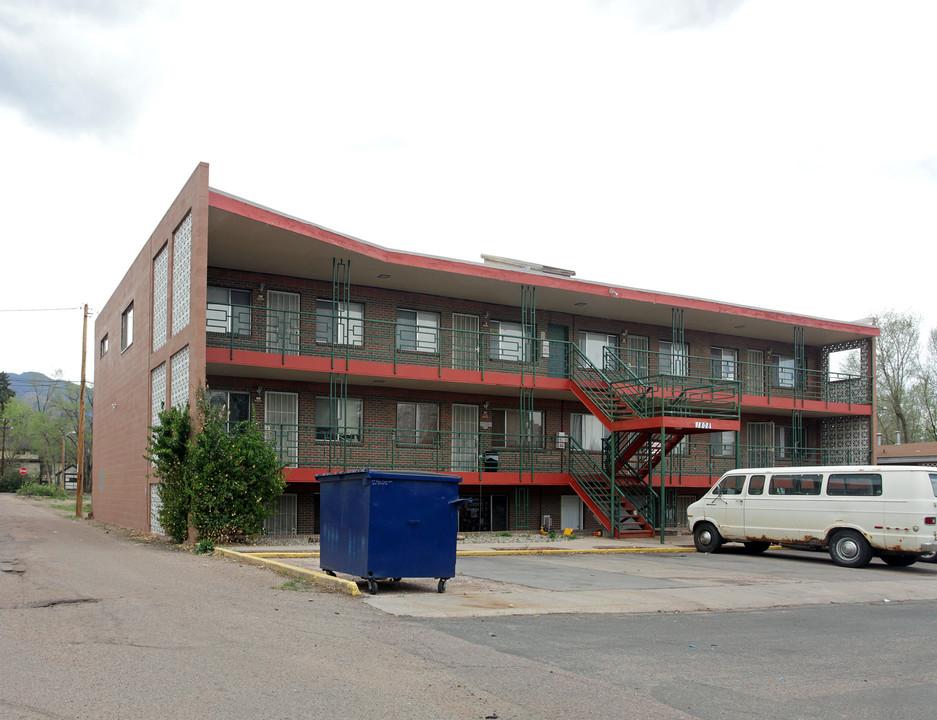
[93,164,878,534]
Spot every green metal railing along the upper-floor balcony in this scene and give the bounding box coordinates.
[206,303,872,404]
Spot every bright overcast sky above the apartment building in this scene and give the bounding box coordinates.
[0,0,937,379]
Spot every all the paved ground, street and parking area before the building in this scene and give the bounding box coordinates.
[0,495,937,720]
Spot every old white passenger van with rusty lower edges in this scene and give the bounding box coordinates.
[687,465,937,567]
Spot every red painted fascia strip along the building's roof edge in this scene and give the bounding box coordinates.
[208,190,879,337]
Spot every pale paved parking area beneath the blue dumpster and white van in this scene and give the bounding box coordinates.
[219,546,937,618]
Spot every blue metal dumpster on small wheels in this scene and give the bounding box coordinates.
[316,469,466,595]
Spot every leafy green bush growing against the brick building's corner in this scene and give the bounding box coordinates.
[146,389,286,542]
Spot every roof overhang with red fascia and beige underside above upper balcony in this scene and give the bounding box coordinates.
[208,190,879,346]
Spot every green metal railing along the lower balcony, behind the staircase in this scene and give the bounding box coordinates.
[264,423,870,478]
